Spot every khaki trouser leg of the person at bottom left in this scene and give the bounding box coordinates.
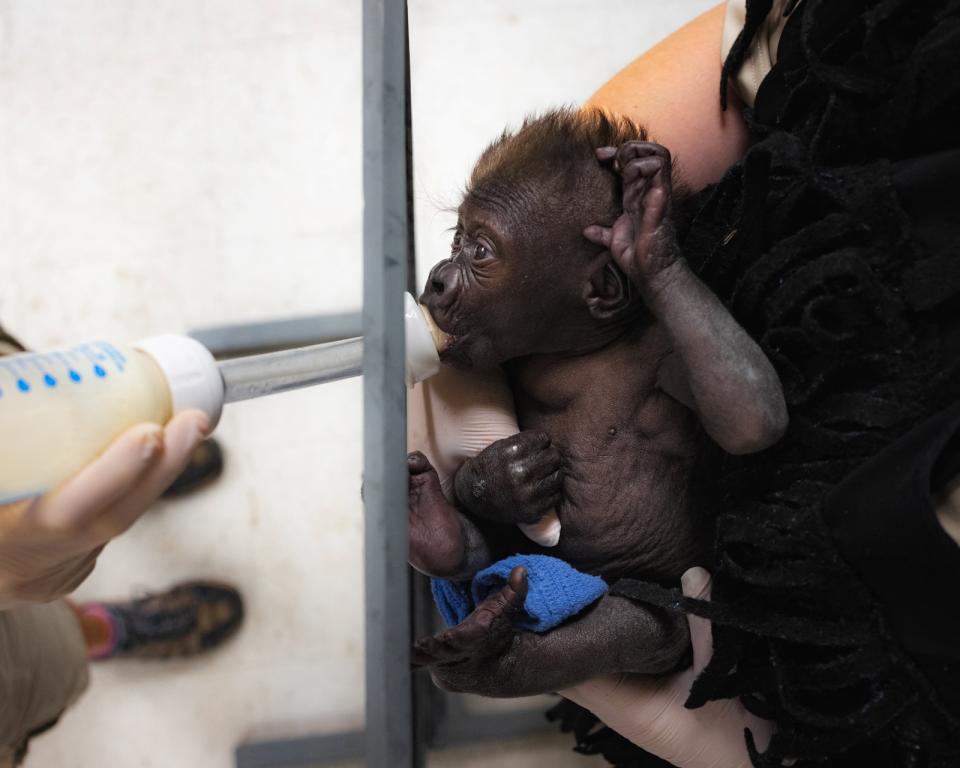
[0,600,88,768]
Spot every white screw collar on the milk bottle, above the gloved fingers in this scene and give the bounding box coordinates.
[133,335,223,431]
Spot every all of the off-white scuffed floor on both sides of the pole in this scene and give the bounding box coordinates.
[0,0,711,768]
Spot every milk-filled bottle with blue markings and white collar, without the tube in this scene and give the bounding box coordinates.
[0,336,223,503]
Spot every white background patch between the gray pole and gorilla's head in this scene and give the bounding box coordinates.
[410,0,717,279]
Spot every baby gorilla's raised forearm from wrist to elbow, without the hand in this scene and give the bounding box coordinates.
[643,258,787,454]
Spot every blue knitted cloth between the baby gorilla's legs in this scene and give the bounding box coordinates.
[430,555,607,632]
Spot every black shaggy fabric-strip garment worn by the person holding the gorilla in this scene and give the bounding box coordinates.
[554,0,960,768]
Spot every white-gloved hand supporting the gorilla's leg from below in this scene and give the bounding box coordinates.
[560,568,774,768]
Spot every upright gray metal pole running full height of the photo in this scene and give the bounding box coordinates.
[363,0,415,768]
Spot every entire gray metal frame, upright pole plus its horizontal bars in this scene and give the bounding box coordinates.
[233,0,549,768]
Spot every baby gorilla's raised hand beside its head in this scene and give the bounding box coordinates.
[583,141,680,291]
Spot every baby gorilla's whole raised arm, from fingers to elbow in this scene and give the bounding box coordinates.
[584,141,787,454]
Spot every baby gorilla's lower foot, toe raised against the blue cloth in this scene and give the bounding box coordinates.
[411,566,527,696]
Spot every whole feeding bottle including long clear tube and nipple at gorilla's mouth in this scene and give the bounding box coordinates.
[0,294,440,504]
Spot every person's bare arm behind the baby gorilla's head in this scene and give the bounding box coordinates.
[587,4,749,190]
